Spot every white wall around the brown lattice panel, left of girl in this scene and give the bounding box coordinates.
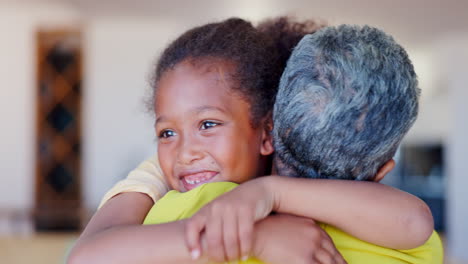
[0,3,194,210]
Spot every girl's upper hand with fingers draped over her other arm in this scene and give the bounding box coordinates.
[185,178,274,262]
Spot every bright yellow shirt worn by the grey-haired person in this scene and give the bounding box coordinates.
[144,182,443,264]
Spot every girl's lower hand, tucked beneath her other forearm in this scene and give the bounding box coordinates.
[253,214,346,264]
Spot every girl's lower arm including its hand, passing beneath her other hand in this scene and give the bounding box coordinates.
[67,193,345,264]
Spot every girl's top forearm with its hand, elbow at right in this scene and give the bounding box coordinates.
[185,176,433,254]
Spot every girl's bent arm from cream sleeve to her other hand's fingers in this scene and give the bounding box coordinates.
[68,193,205,264]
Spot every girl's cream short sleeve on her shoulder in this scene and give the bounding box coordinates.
[99,155,169,208]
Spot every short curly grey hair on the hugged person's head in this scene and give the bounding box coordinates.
[273,25,419,180]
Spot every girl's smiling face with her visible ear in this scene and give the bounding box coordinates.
[155,59,273,192]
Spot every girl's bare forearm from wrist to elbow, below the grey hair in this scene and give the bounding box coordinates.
[266,176,434,249]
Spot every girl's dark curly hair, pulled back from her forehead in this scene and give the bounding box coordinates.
[151,17,319,123]
